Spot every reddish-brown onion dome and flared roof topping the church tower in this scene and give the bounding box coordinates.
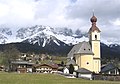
[89,12,100,33]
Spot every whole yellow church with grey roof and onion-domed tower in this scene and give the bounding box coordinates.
[67,14,101,73]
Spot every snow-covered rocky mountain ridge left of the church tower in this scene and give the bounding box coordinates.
[0,25,88,44]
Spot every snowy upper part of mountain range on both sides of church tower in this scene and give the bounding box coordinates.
[0,25,118,47]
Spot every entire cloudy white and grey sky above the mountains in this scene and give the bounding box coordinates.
[0,0,120,42]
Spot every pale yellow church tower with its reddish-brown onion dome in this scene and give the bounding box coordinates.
[89,14,101,73]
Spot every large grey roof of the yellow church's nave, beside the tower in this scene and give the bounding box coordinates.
[67,41,93,58]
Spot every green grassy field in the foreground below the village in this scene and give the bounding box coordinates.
[0,73,120,84]
